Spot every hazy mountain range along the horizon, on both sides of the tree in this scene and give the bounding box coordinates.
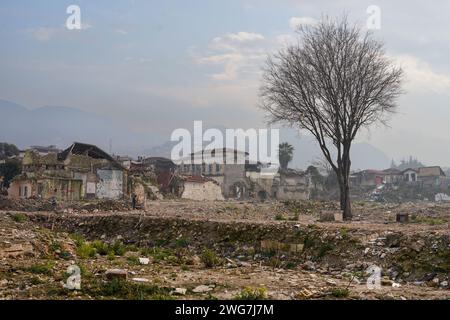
[0,100,390,170]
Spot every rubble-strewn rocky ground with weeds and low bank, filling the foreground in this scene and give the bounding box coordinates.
[0,200,450,299]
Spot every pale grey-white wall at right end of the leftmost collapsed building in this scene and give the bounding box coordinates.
[96,169,124,199]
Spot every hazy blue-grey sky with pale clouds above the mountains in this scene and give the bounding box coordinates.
[0,0,450,166]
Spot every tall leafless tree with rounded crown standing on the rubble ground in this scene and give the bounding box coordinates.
[261,17,403,220]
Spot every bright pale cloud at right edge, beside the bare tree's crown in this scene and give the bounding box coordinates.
[393,54,450,94]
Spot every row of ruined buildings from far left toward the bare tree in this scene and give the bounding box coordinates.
[4,142,311,203]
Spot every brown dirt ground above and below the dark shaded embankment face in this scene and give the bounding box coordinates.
[0,200,450,300]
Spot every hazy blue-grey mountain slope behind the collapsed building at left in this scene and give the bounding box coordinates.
[0,100,161,156]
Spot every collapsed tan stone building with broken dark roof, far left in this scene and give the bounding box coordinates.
[8,142,128,201]
